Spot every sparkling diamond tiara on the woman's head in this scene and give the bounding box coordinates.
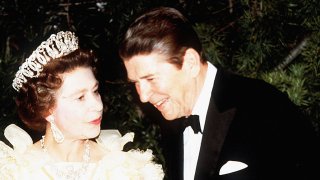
[12,31,78,92]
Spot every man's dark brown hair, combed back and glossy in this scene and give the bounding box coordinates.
[119,7,202,67]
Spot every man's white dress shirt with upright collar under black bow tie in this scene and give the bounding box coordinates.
[183,62,217,180]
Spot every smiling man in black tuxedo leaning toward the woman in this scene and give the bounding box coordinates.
[119,7,320,180]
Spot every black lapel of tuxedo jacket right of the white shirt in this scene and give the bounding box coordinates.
[195,102,236,179]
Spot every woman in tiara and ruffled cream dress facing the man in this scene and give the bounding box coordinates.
[0,32,164,179]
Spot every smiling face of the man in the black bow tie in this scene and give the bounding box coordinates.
[124,53,195,120]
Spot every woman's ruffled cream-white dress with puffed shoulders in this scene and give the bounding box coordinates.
[0,125,164,180]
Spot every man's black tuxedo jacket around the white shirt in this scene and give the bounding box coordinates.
[162,69,320,180]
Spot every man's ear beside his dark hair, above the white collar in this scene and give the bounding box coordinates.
[182,48,201,77]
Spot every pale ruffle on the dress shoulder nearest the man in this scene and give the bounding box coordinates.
[96,130,164,180]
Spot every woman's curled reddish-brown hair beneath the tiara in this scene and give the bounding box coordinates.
[16,49,96,132]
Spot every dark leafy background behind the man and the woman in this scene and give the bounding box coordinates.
[0,0,320,174]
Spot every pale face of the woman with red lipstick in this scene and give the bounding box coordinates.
[53,67,103,139]
